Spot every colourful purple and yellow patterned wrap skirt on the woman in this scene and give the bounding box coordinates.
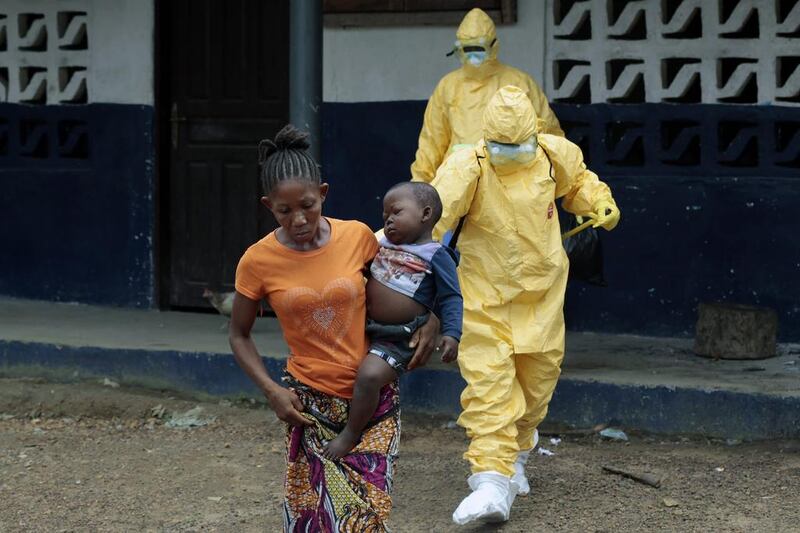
[283,376,400,533]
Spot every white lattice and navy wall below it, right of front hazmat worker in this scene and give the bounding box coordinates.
[546,0,800,339]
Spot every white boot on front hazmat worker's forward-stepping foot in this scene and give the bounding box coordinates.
[453,471,517,526]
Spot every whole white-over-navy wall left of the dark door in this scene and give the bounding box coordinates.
[0,0,154,306]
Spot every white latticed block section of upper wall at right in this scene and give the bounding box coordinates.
[547,0,800,106]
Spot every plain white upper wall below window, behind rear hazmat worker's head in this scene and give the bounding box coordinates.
[322,0,545,102]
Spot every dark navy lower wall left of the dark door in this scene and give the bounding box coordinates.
[0,103,155,307]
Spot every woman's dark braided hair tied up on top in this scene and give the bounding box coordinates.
[258,124,321,196]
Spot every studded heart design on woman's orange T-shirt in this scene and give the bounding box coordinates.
[283,278,358,356]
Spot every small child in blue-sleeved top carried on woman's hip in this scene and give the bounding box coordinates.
[324,182,463,459]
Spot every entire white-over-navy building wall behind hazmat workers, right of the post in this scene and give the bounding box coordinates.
[323,0,800,340]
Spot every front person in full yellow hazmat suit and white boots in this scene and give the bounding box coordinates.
[431,86,620,524]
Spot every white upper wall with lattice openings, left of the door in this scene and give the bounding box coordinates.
[0,0,154,105]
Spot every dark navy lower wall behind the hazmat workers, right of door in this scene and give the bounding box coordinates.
[323,101,800,342]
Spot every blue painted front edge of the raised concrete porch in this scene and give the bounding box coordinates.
[0,341,800,439]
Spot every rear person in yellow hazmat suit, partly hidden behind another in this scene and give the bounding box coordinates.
[411,8,564,183]
